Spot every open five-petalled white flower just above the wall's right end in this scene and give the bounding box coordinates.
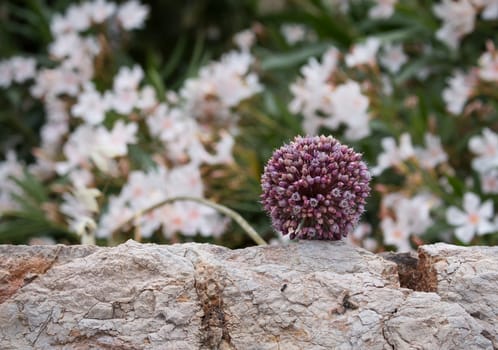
[446,192,497,243]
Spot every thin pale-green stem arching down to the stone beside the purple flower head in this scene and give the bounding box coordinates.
[111,196,267,245]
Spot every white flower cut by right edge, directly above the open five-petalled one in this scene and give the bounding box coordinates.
[469,128,498,172]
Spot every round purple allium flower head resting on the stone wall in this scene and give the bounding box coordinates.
[261,136,370,240]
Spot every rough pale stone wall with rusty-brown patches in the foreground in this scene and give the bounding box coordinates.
[0,241,498,350]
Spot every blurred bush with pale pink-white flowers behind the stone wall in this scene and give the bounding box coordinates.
[0,0,498,250]
